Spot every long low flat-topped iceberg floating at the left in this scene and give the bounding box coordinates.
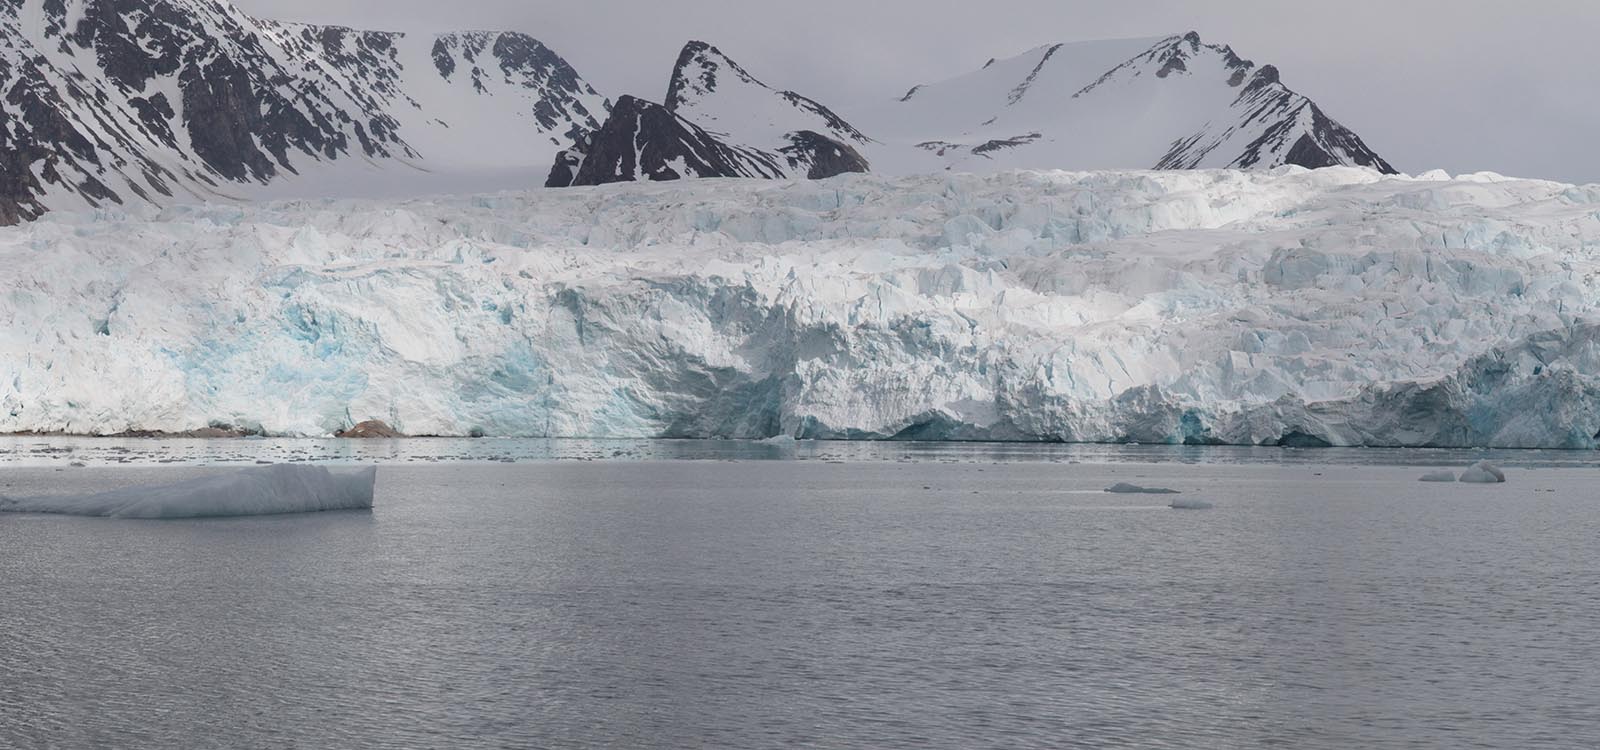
[0,464,378,518]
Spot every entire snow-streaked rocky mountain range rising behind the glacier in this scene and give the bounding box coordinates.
[0,0,1395,224]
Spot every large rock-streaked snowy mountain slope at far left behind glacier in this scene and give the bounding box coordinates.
[0,0,606,224]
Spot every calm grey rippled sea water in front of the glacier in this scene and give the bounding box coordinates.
[0,438,1600,748]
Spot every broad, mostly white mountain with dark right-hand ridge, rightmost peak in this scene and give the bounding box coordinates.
[858,32,1395,173]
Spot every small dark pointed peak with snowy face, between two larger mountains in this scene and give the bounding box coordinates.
[546,42,870,187]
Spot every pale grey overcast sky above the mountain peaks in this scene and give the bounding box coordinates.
[235,0,1600,182]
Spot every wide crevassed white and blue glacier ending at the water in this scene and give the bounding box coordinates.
[0,166,1600,449]
